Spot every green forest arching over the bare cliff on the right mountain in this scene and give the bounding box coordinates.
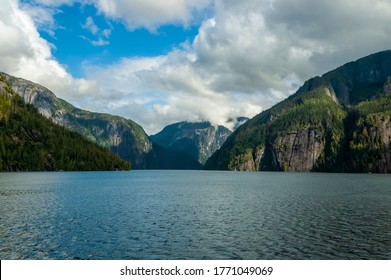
[206,87,346,170]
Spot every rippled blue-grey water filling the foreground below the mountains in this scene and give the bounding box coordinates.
[0,171,391,259]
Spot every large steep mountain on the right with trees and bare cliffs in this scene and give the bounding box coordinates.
[205,51,391,173]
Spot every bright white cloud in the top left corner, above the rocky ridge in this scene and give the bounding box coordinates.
[0,0,94,106]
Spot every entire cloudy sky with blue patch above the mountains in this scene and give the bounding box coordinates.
[0,0,391,134]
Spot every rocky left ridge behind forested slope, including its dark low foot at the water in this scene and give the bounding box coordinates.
[0,73,201,169]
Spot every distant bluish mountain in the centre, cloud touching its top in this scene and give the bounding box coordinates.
[150,117,248,164]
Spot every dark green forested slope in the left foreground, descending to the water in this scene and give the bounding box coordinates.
[0,75,130,171]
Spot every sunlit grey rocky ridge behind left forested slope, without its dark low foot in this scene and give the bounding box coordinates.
[3,73,152,168]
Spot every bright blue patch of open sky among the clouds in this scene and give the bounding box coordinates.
[39,3,199,78]
